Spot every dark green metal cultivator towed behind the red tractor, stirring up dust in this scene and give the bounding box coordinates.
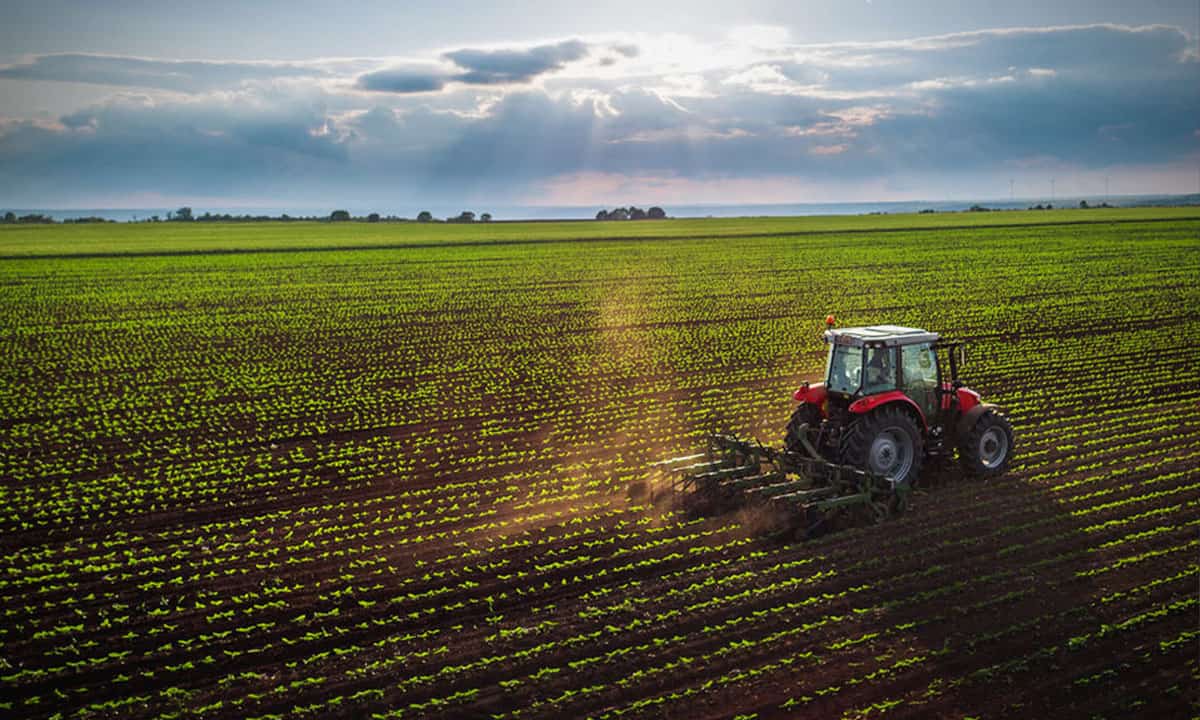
[655,427,910,538]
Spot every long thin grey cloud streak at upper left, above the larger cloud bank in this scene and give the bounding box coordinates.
[0,53,331,92]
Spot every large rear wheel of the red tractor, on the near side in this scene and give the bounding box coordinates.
[842,404,925,487]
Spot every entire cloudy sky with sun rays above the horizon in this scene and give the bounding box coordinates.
[0,0,1200,214]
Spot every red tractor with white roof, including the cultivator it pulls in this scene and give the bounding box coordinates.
[659,316,1013,535]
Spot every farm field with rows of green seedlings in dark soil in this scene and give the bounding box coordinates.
[0,209,1200,720]
